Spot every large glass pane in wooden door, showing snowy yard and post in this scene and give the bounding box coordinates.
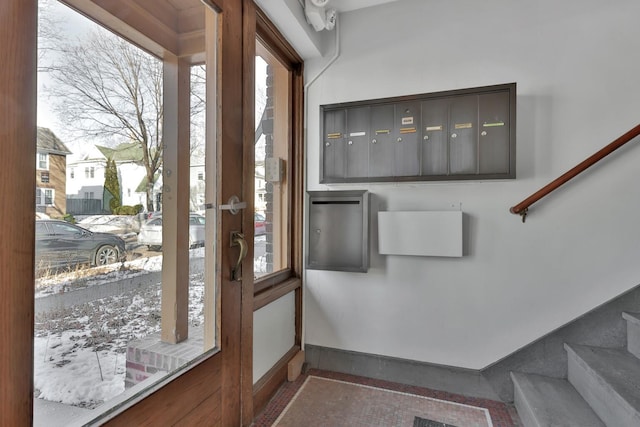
[33,2,219,427]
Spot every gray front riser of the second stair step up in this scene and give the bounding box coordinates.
[567,351,640,427]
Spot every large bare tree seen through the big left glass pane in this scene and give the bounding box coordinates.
[47,29,164,210]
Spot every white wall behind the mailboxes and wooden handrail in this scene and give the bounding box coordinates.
[304,0,640,369]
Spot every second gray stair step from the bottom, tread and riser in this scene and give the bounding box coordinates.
[564,344,640,427]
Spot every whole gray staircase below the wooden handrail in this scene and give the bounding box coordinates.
[511,312,640,427]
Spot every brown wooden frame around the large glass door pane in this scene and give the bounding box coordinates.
[0,0,253,426]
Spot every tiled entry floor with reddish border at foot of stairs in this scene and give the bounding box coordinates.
[254,369,520,427]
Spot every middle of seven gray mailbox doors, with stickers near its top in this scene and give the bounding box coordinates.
[394,102,420,176]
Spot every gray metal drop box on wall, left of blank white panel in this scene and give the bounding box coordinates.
[307,190,369,272]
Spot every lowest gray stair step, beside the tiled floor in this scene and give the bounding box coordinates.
[511,372,604,427]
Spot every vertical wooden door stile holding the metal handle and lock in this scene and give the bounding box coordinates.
[216,0,245,426]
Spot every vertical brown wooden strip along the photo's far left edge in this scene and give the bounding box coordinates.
[0,0,38,426]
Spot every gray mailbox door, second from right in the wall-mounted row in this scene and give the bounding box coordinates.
[449,95,478,175]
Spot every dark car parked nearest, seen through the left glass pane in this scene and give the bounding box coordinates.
[36,219,126,270]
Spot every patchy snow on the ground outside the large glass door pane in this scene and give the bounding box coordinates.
[34,249,204,408]
